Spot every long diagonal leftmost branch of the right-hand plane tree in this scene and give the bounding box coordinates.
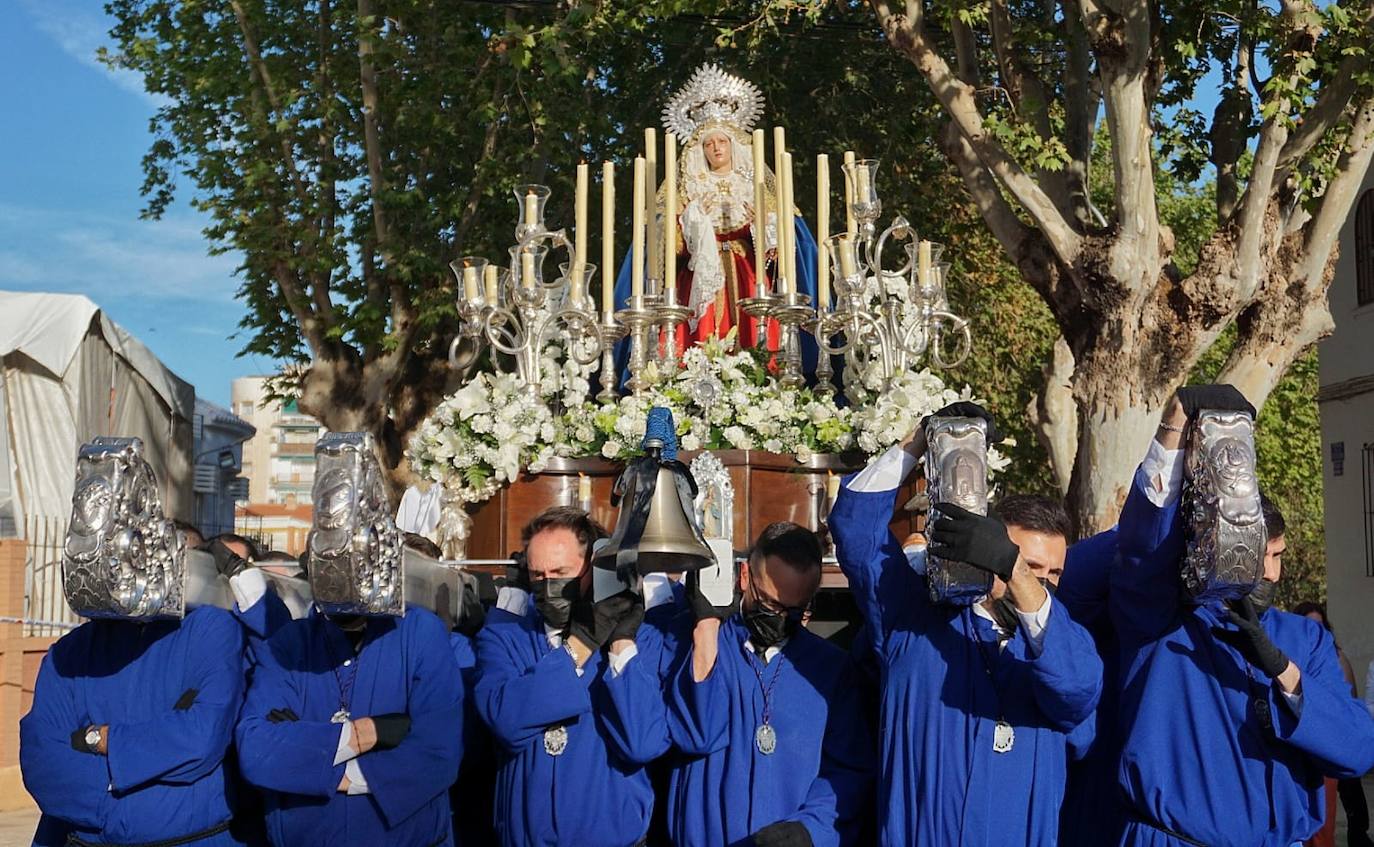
[870,0,1081,265]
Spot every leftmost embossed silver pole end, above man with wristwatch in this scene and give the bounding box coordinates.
[62,437,189,620]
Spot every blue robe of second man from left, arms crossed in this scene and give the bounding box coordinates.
[238,606,463,847]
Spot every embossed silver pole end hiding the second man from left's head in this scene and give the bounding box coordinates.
[306,432,405,617]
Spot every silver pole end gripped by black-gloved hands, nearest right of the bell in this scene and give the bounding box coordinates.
[925,418,992,606]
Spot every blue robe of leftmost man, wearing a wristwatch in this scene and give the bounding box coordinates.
[19,608,243,846]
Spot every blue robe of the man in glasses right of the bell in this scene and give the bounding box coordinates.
[654,612,872,847]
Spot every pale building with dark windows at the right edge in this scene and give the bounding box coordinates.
[1318,172,1374,694]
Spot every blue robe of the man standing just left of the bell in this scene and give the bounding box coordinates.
[473,609,668,847]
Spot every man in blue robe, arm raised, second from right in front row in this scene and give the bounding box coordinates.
[830,404,1102,847]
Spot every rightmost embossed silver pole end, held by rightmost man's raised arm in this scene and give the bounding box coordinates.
[1182,410,1268,602]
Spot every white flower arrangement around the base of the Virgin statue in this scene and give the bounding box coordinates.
[408,328,1007,503]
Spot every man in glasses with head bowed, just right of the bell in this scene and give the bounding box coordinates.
[654,521,874,847]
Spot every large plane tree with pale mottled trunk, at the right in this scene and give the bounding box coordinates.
[752,0,1374,531]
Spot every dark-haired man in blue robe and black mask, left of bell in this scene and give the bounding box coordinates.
[474,507,668,847]
